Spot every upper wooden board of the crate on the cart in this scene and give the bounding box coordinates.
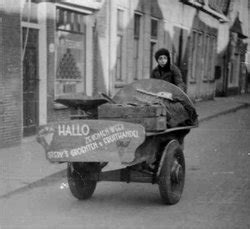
[98,104,166,119]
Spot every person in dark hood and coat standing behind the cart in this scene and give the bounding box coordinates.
[151,48,185,91]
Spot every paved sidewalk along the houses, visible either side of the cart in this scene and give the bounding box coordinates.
[0,94,250,198]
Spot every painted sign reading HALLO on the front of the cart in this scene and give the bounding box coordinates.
[37,120,145,162]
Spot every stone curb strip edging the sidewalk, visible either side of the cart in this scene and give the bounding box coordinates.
[0,103,250,199]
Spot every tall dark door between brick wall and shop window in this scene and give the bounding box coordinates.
[23,28,39,136]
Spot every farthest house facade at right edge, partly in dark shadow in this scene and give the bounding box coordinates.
[216,0,249,96]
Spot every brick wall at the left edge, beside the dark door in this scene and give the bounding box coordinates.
[0,0,22,147]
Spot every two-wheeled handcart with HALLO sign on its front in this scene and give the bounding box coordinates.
[37,80,198,205]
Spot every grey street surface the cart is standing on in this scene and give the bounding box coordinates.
[0,108,250,229]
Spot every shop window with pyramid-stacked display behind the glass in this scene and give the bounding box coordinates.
[56,8,86,96]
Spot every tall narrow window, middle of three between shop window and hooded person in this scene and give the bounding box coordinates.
[133,13,141,80]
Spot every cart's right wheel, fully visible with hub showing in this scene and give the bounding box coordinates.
[158,140,185,205]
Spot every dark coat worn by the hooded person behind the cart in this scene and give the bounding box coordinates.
[151,64,185,91]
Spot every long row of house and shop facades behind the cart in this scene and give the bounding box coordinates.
[0,0,248,147]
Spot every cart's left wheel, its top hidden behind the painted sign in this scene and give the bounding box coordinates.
[67,162,98,200]
